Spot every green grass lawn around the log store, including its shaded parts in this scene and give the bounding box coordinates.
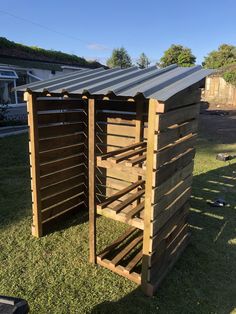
[0,135,236,314]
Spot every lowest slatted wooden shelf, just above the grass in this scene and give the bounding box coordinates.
[97,227,143,284]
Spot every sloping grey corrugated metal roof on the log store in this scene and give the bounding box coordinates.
[16,64,213,101]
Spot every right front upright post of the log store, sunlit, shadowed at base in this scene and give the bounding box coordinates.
[141,99,157,294]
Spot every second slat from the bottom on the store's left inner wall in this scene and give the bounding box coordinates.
[42,193,84,222]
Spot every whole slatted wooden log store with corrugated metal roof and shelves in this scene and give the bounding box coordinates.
[17,65,213,296]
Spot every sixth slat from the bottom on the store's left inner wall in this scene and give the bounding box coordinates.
[40,153,85,176]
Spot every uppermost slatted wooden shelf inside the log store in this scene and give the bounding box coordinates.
[97,142,147,175]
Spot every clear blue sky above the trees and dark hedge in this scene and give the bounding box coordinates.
[0,0,236,63]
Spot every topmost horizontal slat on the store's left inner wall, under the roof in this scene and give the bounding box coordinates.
[36,99,87,111]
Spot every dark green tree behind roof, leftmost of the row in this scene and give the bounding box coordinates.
[107,47,132,68]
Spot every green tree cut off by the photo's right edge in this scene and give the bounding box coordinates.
[202,44,236,69]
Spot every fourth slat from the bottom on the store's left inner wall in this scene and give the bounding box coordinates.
[40,173,86,198]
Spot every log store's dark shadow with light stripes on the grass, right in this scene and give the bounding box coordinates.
[91,164,236,314]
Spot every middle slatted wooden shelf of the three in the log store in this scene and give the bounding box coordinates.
[97,180,145,230]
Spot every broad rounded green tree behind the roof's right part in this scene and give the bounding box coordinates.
[159,45,196,68]
